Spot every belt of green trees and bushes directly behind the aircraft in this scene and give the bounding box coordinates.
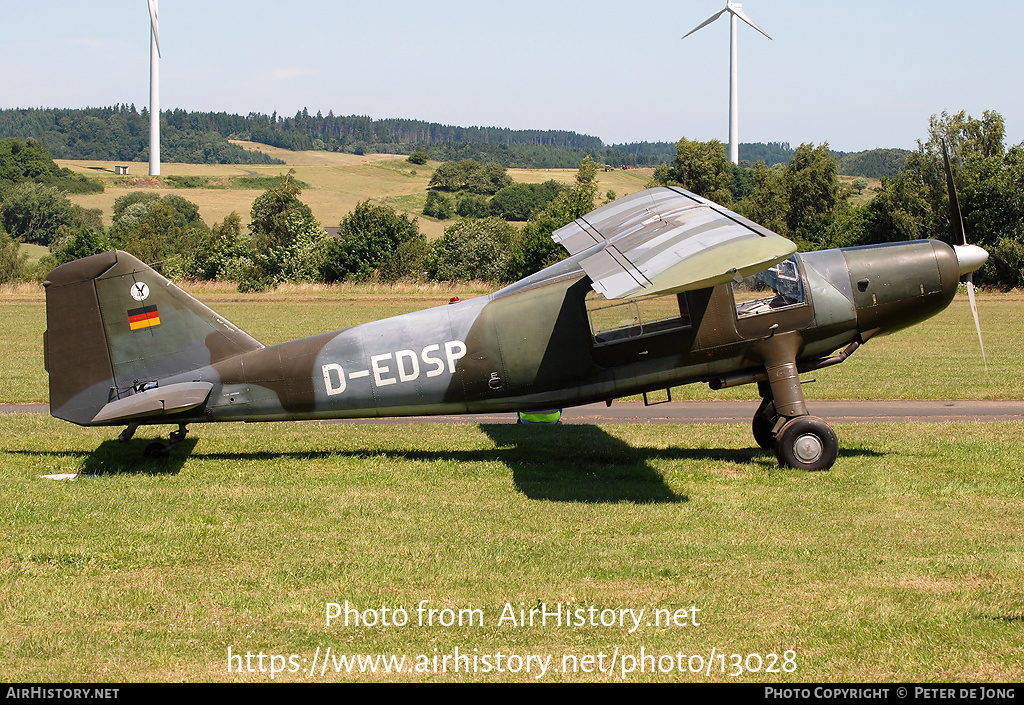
[0,111,1024,290]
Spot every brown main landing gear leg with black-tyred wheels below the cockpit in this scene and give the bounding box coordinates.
[751,333,839,470]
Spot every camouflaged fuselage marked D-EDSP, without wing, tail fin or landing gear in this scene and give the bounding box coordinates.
[142,241,959,423]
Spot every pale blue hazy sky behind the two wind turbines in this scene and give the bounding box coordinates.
[0,0,1024,152]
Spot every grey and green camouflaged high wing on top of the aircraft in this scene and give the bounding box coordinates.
[551,186,797,299]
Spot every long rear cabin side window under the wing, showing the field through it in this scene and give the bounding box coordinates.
[587,291,690,345]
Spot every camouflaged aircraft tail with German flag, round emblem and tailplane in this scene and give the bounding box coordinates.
[43,251,263,425]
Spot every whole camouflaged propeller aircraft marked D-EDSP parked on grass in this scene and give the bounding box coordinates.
[44,186,987,470]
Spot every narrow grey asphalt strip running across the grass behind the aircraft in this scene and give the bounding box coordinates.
[9,400,1024,425]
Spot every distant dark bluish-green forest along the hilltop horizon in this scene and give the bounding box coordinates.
[0,105,909,178]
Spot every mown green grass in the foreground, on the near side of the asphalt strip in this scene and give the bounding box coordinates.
[0,415,1024,681]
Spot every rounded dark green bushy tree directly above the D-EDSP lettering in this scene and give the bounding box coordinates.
[322,201,426,282]
